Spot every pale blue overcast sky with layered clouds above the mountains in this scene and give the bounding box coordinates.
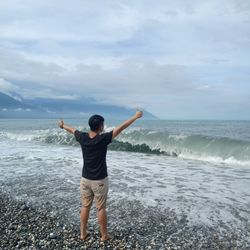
[0,0,250,119]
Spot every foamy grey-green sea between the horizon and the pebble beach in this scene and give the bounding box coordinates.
[0,119,250,240]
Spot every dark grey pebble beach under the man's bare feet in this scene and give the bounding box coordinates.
[0,192,249,250]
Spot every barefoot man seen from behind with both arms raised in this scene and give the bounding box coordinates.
[58,111,143,241]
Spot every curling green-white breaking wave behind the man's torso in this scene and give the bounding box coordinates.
[0,129,250,165]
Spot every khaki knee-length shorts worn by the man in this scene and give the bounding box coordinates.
[80,177,109,209]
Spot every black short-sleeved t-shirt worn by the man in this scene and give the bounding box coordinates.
[75,130,113,180]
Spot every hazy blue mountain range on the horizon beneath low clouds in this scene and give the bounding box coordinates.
[0,92,157,119]
